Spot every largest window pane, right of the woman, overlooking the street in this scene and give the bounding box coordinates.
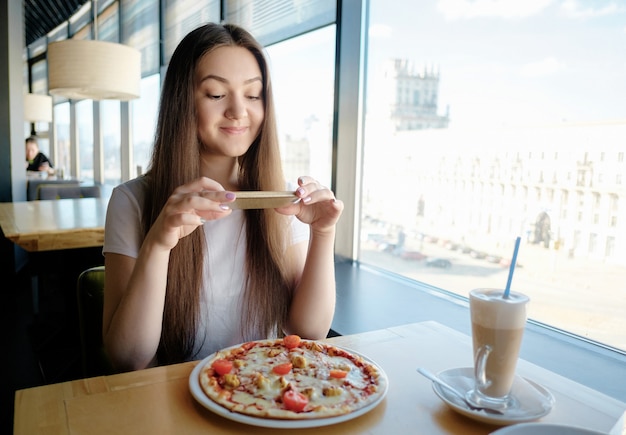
[360,0,626,349]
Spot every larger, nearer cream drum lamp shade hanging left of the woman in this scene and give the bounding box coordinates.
[48,39,141,101]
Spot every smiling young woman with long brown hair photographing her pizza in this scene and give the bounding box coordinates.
[103,24,343,370]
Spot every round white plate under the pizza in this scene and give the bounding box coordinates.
[189,345,389,429]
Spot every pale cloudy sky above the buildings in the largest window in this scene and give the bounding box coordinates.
[368,0,626,127]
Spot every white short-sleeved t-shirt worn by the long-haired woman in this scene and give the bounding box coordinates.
[103,176,309,359]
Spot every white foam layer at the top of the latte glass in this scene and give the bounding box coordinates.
[470,289,528,329]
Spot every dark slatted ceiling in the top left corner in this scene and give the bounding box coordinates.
[24,0,89,46]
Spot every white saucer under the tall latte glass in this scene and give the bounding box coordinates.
[433,367,554,426]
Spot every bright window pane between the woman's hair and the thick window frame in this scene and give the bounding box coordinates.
[267,25,335,186]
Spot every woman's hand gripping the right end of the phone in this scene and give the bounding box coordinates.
[277,176,343,232]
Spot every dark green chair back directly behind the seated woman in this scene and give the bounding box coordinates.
[77,266,113,377]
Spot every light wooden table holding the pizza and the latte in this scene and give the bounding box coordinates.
[14,322,626,435]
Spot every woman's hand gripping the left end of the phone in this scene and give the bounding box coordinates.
[144,177,235,250]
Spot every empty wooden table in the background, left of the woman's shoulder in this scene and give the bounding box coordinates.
[0,198,108,252]
